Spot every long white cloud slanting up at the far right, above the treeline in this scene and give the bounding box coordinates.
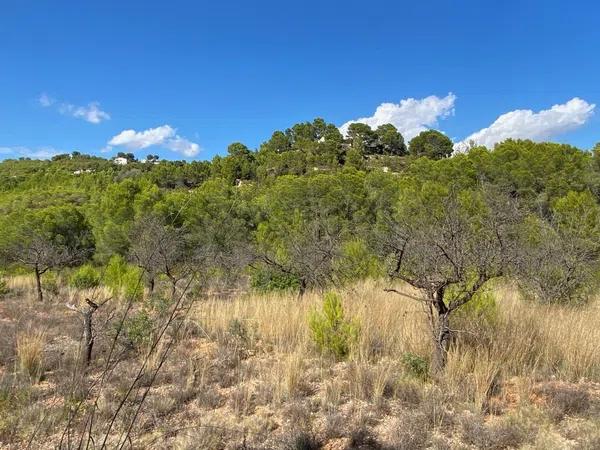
[454,97,596,151]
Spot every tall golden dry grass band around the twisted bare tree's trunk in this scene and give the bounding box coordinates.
[198,282,600,389]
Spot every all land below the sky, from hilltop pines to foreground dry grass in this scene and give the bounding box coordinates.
[0,125,600,449]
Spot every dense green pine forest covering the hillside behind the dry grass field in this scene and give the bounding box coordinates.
[0,119,600,301]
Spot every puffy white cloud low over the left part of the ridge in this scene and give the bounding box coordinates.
[108,125,200,157]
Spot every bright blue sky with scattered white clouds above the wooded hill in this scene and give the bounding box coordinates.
[0,0,600,159]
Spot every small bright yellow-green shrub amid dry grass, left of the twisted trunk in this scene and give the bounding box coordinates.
[308,292,360,358]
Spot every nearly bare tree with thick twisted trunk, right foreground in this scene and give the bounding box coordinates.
[378,183,520,374]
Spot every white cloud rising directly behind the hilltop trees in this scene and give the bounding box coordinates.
[340,93,456,141]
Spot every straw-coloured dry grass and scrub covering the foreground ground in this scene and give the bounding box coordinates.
[0,277,600,449]
